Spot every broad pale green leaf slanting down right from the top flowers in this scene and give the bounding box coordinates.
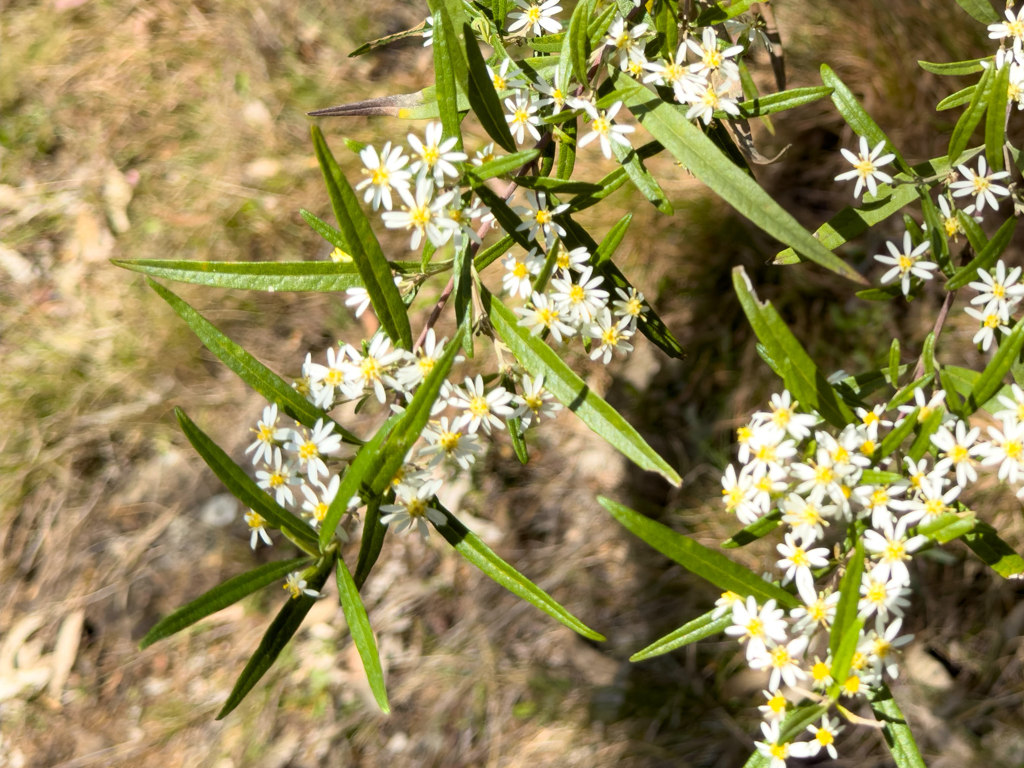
[613,70,866,285]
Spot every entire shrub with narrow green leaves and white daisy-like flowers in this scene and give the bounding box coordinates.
[119,0,1024,768]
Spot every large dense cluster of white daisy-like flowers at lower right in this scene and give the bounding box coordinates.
[715,378,1024,762]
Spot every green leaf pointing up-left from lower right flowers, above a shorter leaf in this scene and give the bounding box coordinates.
[597,496,799,608]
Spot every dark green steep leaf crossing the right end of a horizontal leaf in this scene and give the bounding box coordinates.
[311,125,413,349]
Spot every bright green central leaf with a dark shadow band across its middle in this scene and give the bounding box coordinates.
[480,288,681,485]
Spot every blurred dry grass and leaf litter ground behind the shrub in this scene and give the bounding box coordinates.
[0,0,1024,768]
